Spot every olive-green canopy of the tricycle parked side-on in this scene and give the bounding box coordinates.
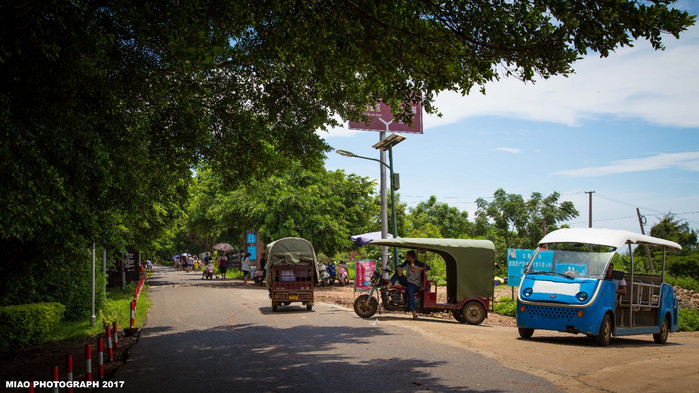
[370,238,495,301]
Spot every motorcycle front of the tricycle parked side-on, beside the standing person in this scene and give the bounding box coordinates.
[354,269,424,318]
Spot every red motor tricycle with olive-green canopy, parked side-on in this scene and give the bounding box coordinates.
[354,238,495,325]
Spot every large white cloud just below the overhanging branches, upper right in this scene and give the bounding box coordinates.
[425,26,699,128]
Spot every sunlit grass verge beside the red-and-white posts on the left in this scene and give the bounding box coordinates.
[46,285,151,343]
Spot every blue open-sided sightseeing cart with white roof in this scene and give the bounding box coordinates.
[517,228,681,346]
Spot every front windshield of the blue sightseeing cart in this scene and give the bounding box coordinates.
[525,243,616,279]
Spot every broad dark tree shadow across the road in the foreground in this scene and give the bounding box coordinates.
[114,322,496,392]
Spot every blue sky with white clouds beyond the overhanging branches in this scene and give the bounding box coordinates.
[320,1,699,232]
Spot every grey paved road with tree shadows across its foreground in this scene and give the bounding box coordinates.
[113,267,560,392]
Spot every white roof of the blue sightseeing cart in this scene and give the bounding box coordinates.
[539,228,682,250]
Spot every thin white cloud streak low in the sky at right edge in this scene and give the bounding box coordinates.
[552,152,699,177]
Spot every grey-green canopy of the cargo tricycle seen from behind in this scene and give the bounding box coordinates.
[266,237,320,287]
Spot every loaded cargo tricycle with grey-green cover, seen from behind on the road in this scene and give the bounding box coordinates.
[266,237,319,311]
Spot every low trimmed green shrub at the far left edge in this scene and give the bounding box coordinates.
[0,303,66,348]
